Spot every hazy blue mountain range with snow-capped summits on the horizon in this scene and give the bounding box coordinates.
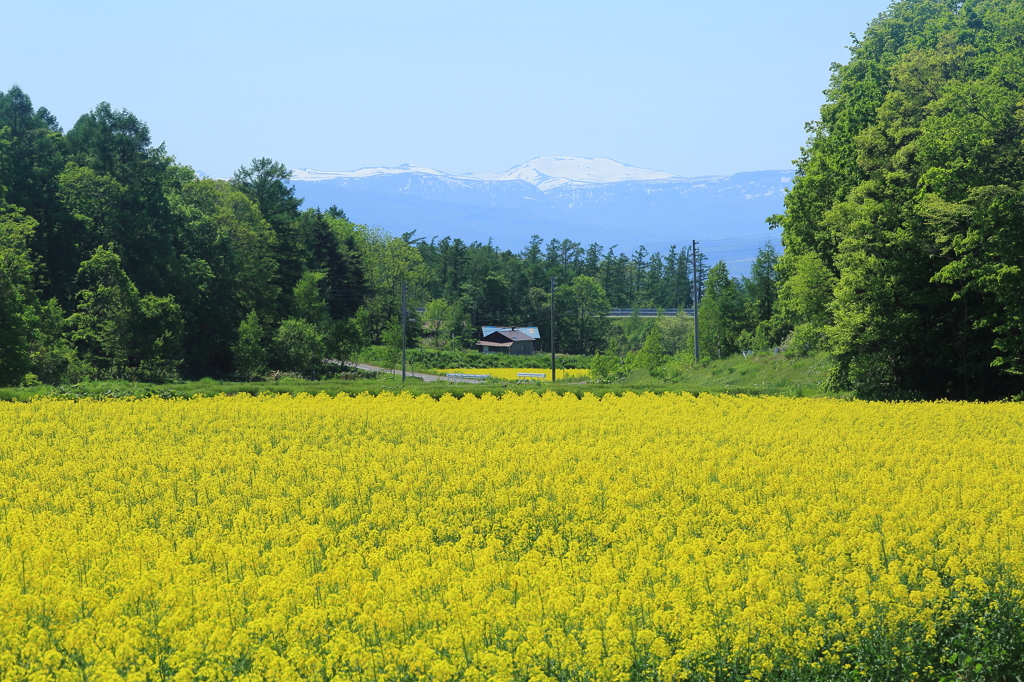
[292,157,793,261]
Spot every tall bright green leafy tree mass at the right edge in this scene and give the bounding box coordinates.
[774,0,1024,399]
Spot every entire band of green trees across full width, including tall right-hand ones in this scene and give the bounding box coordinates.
[6,0,1024,399]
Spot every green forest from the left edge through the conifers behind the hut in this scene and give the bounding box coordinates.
[0,86,737,384]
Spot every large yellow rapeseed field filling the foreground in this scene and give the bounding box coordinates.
[0,392,1024,681]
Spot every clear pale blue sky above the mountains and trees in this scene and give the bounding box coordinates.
[0,0,889,177]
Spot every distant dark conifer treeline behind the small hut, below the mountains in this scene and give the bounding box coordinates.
[404,235,707,354]
